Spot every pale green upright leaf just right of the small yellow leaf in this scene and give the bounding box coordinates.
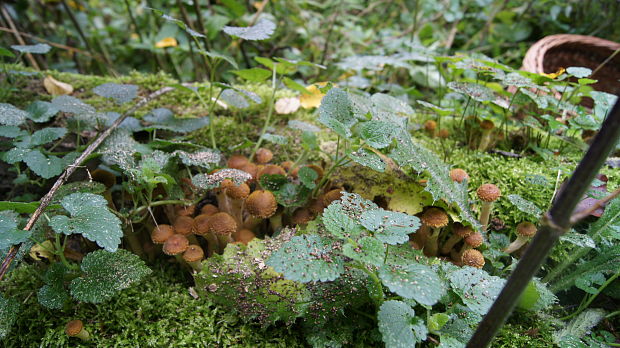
[318,87,357,138]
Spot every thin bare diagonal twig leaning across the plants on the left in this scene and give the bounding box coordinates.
[0,87,174,280]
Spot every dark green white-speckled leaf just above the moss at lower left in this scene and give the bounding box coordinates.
[70,249,152,303]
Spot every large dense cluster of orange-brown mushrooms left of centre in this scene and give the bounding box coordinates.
[151,148,342,271]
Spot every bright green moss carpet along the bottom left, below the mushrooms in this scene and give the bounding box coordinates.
[0,265,303,348]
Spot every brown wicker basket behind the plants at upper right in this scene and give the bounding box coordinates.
[521,34,620,106]
